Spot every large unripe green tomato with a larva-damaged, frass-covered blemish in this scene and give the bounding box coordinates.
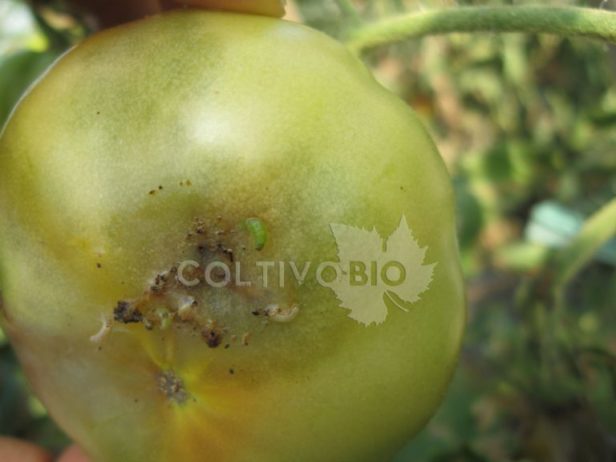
[0,11,465,462]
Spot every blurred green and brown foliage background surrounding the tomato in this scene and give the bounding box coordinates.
[0,0,616,462]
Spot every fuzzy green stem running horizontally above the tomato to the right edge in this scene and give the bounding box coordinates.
[347,6,616,54]
